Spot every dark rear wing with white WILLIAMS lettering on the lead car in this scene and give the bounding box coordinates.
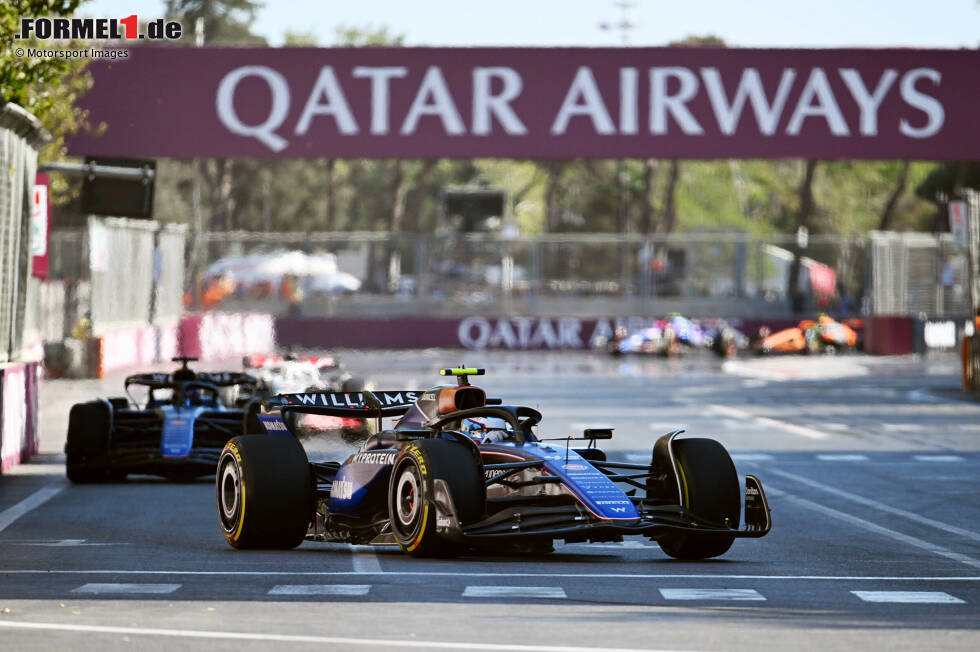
[262,389,426,418]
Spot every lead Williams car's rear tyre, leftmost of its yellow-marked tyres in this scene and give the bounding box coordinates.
[215,435,314,550]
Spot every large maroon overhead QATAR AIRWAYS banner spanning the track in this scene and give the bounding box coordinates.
[69,47,980,160]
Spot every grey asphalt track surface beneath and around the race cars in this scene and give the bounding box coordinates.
[0,350,980,652]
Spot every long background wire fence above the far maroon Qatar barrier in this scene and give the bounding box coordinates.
[196,232,868,316]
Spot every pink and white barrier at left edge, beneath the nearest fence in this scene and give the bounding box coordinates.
[0,362,43,473]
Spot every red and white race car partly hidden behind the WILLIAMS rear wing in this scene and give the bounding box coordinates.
[242,353,363,397]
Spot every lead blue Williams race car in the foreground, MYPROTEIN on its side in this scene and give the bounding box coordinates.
[216,369,771,559]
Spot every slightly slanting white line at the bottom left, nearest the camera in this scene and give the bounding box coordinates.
[0,621,680,652]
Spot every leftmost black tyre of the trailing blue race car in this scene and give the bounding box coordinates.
[65,401,112,484]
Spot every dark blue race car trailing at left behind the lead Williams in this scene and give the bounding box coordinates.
[65,357,261,483]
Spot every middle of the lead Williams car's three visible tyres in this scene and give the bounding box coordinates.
[388,439,486,557]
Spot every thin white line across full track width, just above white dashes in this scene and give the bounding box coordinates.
[0,568,980,580]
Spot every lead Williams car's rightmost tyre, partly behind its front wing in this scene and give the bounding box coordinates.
[657,438,742,560]
